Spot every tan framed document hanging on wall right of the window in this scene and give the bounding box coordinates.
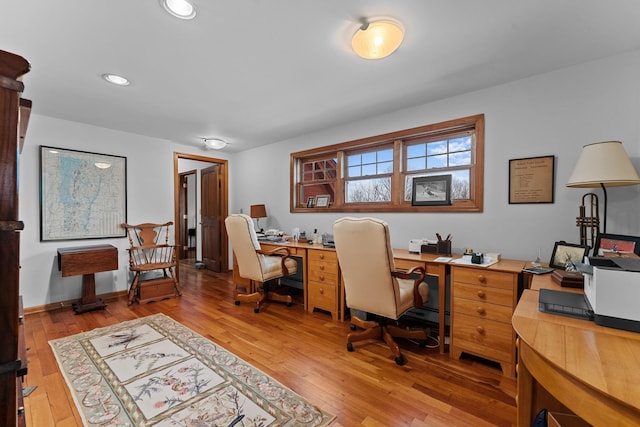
[509,156,555,204]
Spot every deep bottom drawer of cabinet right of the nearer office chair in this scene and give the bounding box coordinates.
[452,313,515,363]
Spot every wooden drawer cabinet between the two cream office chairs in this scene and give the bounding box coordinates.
[307,248,344,320]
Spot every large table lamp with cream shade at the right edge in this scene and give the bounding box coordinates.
[567,141,640,233]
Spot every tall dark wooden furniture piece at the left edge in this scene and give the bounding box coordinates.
[0,50,31,427]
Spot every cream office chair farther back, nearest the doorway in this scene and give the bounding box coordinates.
[224,214,298,313]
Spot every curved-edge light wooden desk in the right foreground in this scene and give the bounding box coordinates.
[512,290,640,427]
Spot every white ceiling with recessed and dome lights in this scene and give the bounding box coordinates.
[0,0,640,152]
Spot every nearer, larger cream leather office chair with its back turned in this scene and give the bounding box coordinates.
[333,217,429,365]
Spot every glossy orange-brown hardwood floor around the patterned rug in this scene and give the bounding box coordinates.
[24,266,516,427]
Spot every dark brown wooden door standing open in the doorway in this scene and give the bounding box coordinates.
[200,164,224,273]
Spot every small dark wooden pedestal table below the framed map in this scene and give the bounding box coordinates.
[58,245,118,314]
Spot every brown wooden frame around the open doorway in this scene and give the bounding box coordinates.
[173,152,229,272]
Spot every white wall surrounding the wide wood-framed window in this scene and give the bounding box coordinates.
[230,52,640,260]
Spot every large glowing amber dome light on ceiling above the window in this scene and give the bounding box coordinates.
[351,18,404,59]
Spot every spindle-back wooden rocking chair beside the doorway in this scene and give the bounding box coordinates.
[122,221,182,305]
